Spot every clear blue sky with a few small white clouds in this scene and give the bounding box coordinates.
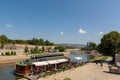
[0,0,120,44]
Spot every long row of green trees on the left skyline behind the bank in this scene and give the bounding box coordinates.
[0,35,54,49]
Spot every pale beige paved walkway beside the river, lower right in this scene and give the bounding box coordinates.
[39,57,120,80]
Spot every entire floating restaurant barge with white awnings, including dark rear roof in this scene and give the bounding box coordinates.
[15,53,69,77]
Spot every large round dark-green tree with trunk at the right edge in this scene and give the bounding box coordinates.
[98,31,120,62]
